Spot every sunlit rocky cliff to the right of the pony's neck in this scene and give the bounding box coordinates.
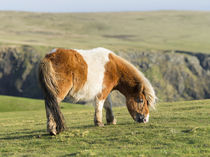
[116,51,210,101]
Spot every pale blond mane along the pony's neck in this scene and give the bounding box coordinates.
[119,54,157,109]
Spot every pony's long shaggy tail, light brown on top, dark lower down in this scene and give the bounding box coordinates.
[39,58,66,135]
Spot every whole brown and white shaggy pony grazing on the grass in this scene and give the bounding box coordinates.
[39,48,156,135]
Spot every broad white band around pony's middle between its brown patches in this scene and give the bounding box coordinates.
[70,48,113,101]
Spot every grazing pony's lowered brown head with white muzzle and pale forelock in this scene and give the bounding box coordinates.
[126,86,156,123]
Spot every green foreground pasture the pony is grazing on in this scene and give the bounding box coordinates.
[0,96,210,157]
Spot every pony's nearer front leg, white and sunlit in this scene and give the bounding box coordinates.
[94,97,104,126]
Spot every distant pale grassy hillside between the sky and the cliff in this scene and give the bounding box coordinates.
[0,11,210,53]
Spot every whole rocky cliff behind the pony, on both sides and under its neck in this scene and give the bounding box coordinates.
[0,46,210,105]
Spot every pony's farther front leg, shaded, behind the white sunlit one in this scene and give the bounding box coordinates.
[104,95,117,124]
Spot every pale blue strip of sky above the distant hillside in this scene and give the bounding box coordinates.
[0,0,210,12]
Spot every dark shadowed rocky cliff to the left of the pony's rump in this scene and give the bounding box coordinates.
[0,46,41,98]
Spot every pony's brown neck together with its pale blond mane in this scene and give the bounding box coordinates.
[110,53,157,108]
